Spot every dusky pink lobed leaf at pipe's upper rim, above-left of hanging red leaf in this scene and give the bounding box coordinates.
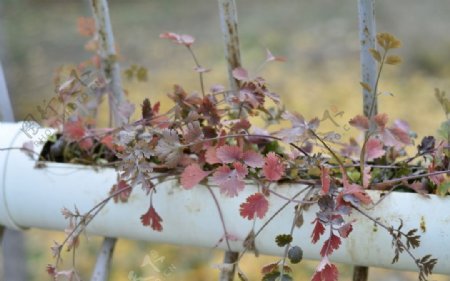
[212,162,248,197]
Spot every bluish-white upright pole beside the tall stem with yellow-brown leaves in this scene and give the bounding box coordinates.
[358,0,378,116]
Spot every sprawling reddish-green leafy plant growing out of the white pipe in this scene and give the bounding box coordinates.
[40,27,450,281]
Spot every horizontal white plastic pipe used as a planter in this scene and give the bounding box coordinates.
[0,121,450,274]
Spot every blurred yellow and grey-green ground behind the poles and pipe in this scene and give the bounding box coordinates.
[0,0,450,281]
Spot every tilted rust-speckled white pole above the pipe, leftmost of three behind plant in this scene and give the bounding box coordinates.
[91,0,125,127]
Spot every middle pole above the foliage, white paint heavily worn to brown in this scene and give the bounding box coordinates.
[218,0,241,93]
